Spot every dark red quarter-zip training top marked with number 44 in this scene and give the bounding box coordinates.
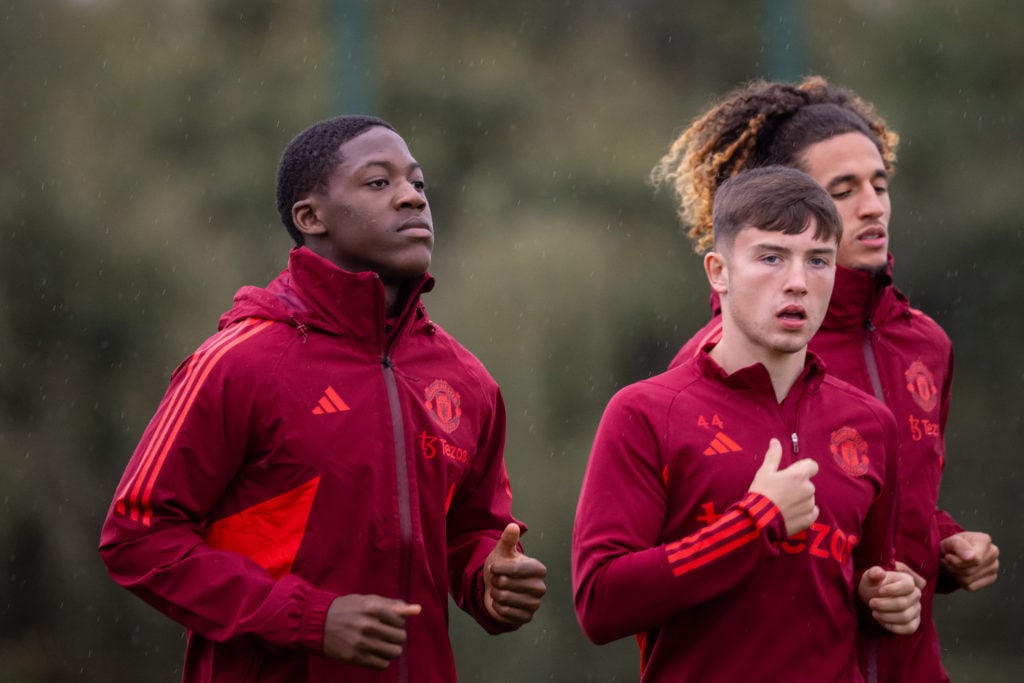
[572,352,896,683]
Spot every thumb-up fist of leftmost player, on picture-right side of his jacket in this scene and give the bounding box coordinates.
[483,522,548,625]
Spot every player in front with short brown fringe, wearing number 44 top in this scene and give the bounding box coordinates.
[572,166,921,683]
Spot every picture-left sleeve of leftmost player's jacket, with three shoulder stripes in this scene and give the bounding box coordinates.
[99,323,336,652]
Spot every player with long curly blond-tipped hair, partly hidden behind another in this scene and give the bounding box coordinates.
[652,77,998,683]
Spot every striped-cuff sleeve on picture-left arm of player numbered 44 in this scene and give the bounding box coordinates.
[572,388,785,643]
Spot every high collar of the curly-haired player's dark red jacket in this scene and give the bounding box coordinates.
[821,254,909,330]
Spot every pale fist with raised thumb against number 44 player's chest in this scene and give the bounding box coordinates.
[749,438,818,536]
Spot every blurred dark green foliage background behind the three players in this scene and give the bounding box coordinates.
[0,0,1024,682]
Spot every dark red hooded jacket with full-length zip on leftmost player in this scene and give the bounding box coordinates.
[99,248,515,683]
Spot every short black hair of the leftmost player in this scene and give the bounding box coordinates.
[278,116,398,247]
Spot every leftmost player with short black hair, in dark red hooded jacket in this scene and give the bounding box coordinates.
[100,117,546,683]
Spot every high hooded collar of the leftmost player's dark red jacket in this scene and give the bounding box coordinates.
[221,247,434,338]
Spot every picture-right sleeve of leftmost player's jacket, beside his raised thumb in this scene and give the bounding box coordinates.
[446,389,526,634]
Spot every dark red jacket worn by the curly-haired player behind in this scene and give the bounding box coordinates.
[672,256,963,683]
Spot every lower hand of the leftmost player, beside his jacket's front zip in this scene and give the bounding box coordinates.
[324,594,422,669]
